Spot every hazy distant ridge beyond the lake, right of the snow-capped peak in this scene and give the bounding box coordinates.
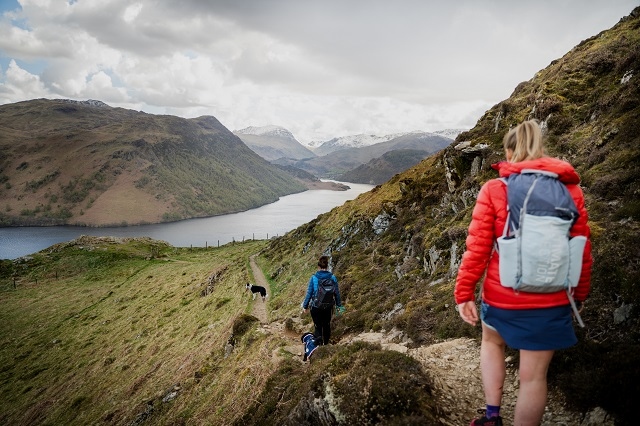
[278,132,452,179]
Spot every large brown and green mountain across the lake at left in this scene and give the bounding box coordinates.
[0,99,305,226]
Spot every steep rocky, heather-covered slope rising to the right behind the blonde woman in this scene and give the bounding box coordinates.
[256,8,640,424]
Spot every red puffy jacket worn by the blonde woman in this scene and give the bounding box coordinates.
[454,157,593,309]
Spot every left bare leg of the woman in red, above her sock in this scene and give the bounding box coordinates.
[480,324,506,405]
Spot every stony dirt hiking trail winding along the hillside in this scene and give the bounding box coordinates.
[249,255,614,426]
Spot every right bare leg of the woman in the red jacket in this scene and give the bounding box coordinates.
[513,349,553,426]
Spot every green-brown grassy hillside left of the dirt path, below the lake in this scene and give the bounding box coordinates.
[0,237,279,425]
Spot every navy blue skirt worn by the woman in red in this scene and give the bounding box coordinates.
[480,302,578,351]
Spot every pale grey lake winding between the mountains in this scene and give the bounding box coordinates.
[0,182,373,259]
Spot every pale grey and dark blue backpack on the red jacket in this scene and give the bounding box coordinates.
[497,169,587,325]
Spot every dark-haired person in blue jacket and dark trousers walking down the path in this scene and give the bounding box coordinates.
[302,256,344,345]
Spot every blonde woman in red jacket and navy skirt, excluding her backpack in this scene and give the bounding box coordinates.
[454,120,592,426]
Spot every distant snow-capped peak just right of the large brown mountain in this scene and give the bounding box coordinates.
[233,126,315,161]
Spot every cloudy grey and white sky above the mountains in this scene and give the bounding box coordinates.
[0,0,640,143]
